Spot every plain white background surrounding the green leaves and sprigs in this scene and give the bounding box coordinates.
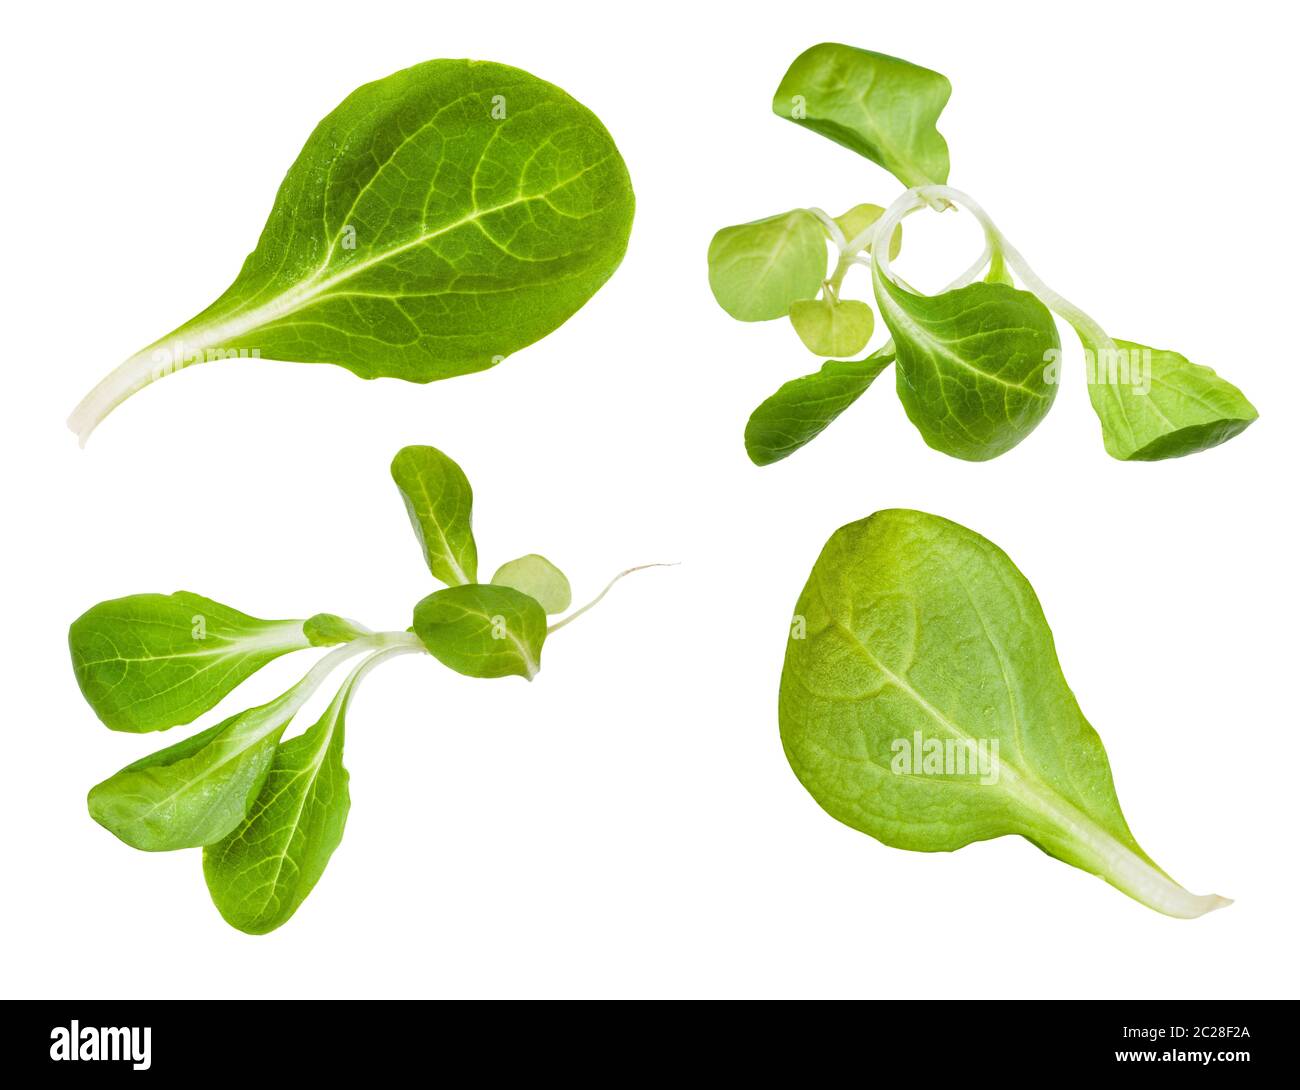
[0,0,1300,998]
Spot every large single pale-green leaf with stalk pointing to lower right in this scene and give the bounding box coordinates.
[780,511,1227,917]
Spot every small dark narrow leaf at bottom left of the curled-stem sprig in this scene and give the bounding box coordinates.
[745,345,893,466]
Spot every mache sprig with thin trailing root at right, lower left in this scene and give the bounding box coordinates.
[69,446,654,934]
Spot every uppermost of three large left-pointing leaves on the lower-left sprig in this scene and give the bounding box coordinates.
[68,591,311,732]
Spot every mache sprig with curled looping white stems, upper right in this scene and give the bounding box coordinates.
[709,43,1258,466]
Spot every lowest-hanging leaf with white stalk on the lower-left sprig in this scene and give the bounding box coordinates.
[203,650,384,935]
